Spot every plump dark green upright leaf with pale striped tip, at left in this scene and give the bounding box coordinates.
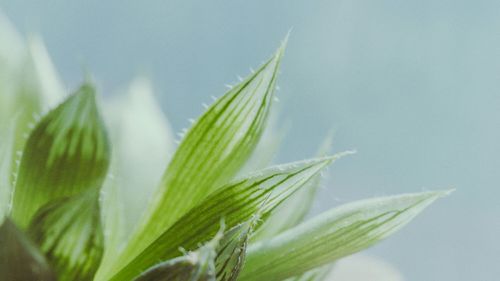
[12,84,110,227]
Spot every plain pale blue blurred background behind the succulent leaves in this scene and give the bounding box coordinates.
[0,0,500,281]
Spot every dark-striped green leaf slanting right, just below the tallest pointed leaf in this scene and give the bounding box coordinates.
[100,155,342,280]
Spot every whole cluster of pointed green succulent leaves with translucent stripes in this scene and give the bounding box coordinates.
[0,15,449,281]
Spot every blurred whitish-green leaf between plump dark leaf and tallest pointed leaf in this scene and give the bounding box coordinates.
[106,78,174,232]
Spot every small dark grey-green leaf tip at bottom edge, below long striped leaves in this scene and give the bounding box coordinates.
[134,230,220,281]
